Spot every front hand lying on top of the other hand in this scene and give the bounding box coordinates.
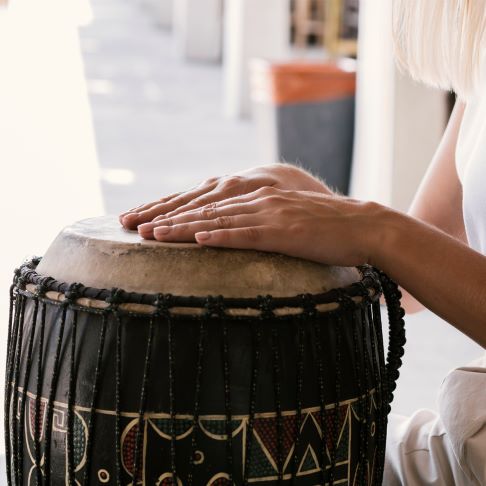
[139,187,382,266]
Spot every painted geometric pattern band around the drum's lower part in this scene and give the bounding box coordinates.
[15,390,376,486]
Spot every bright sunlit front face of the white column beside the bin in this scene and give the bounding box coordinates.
[350,0,395,205]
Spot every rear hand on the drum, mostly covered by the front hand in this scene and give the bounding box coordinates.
[120,163,333,237]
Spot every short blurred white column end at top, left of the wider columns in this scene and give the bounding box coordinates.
[173,0,223,62]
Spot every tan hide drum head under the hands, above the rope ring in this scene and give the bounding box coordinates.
[37,216,361,298]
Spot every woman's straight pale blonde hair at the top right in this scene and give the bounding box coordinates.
[393,0,486,99]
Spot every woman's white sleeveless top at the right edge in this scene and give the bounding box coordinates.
[456,62,486,255]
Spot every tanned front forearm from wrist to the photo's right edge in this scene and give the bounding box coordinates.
[369,206,486,347]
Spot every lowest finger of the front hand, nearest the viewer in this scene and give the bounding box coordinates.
[195,225,277,251]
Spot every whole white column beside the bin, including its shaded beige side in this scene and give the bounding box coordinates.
[351,0,447,211]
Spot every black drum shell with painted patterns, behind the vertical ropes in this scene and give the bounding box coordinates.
[10,297,386,485]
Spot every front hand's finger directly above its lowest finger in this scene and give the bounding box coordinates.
[148,215,258,242]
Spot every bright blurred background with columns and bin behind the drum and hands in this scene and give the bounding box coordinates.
[0,0,481,466]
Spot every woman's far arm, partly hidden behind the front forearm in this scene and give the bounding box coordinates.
[402,102,467,313]
